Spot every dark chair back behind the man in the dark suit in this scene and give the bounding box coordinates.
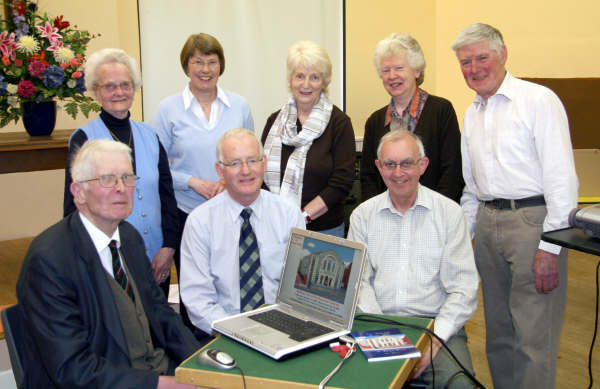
[2,304,25,389]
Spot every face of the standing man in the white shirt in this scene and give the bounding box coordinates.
[456,41,506,101]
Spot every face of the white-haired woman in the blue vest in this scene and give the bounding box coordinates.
[94,63,134,119]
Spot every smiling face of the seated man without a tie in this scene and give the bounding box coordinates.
[375,136,429,212]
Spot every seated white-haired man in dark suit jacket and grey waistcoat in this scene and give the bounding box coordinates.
[17,139,200,389]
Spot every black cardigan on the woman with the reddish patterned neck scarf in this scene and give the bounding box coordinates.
[360,95,465,203]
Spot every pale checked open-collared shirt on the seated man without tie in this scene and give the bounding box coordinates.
[348,185,479,340]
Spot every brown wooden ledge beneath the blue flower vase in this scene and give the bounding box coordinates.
[0,130,74,174]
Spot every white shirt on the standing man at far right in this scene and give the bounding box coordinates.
[461,72,578,254]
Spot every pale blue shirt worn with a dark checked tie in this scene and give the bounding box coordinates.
[179,190,306,334]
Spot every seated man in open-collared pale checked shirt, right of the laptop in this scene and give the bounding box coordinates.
[348,130,479,388]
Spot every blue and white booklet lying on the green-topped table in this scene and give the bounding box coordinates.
[352,328,421,362]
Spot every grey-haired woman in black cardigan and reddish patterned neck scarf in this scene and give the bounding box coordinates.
[360,33,464,202]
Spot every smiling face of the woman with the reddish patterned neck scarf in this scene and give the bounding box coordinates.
[379,55,421,105]
